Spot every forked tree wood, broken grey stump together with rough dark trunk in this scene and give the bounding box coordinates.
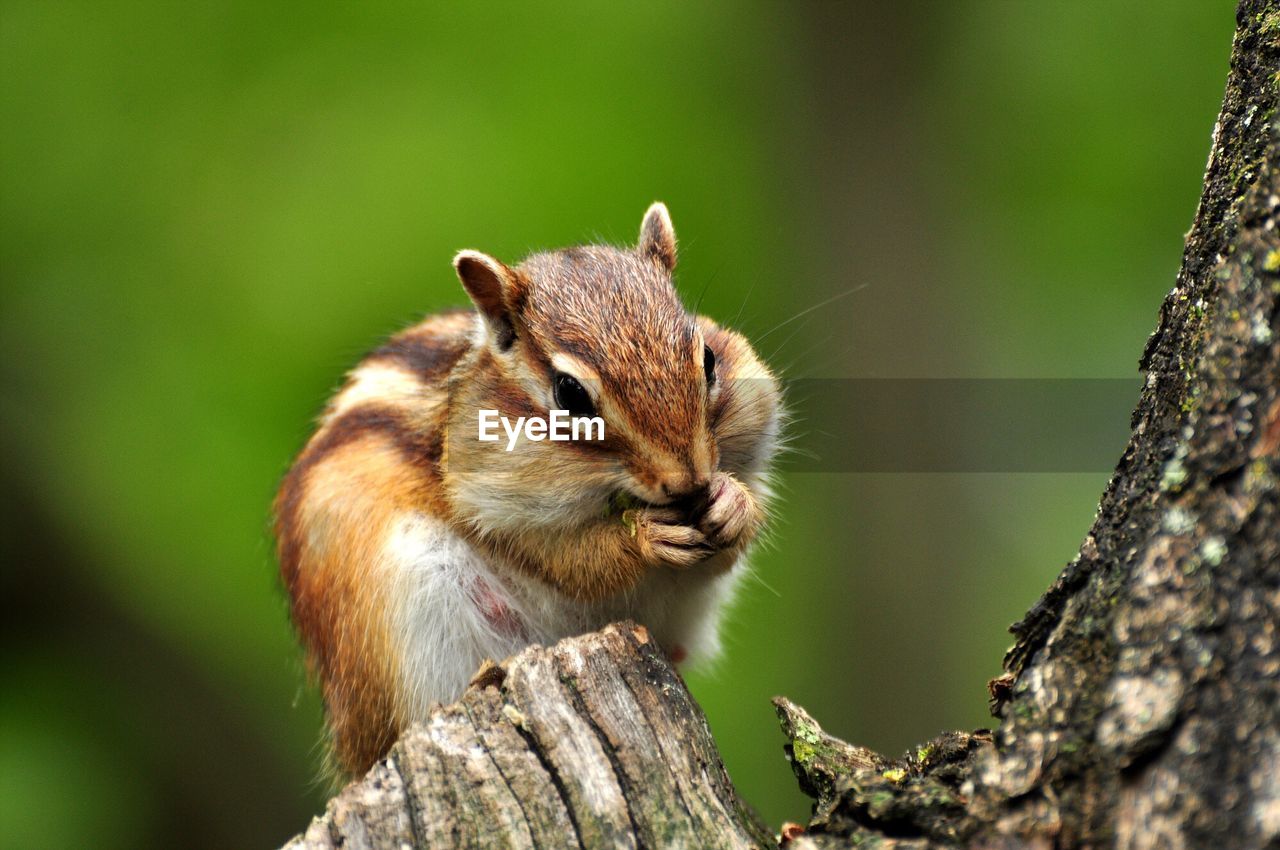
[289,0,1280,849]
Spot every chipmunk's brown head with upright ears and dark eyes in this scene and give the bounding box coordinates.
[448,204,742,525]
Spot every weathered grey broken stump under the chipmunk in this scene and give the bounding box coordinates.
[289,623,773,850]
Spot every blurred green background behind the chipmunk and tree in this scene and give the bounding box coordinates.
[0,0,1233,847]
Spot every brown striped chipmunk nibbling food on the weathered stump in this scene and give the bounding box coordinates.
[275,204,781,776]
